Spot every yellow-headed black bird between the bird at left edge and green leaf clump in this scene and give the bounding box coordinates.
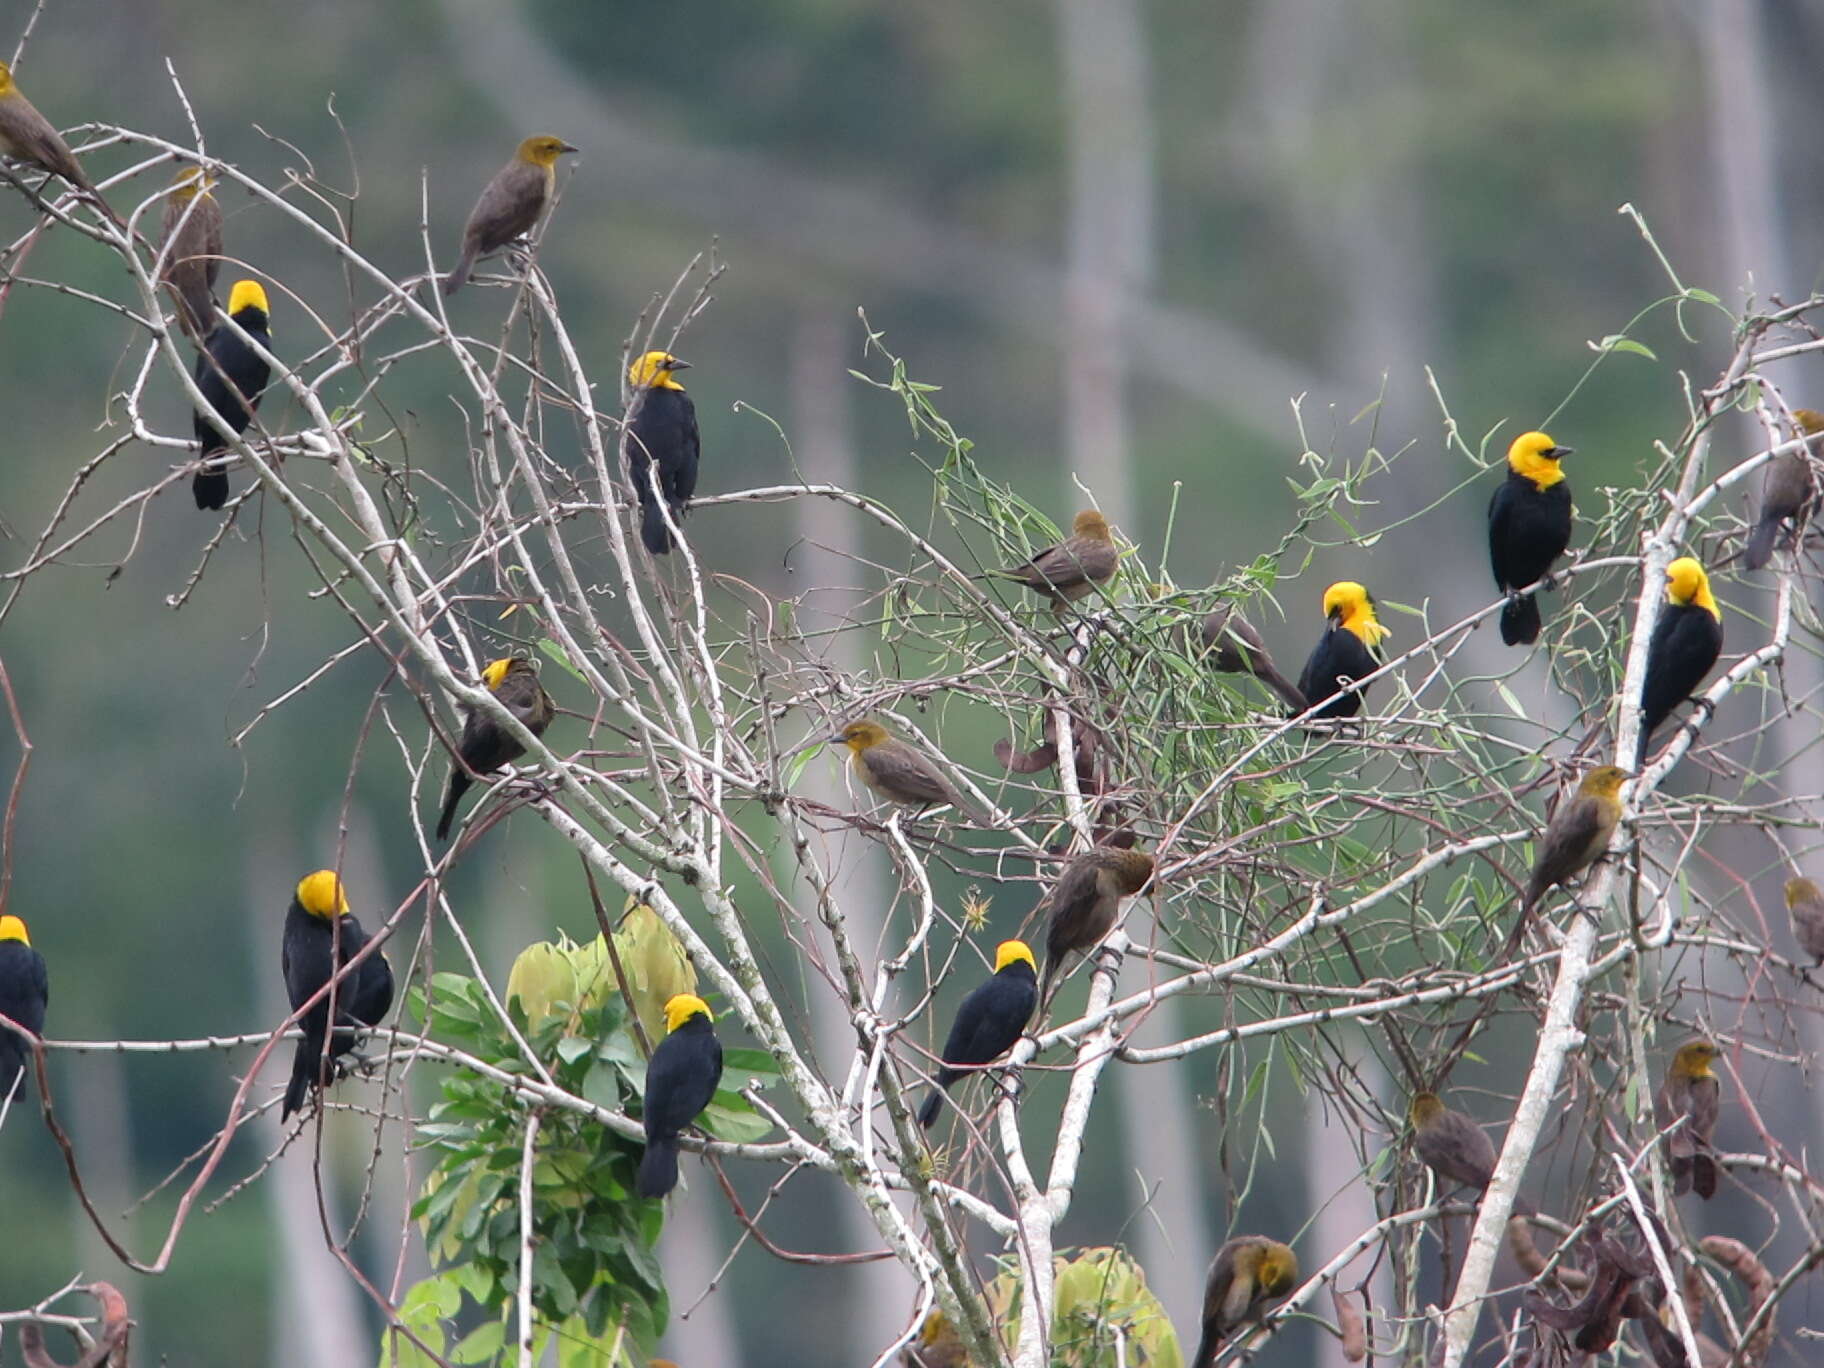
[279,870,392,1120]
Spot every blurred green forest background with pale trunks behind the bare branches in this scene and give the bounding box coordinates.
[0,0,1824,1368]
